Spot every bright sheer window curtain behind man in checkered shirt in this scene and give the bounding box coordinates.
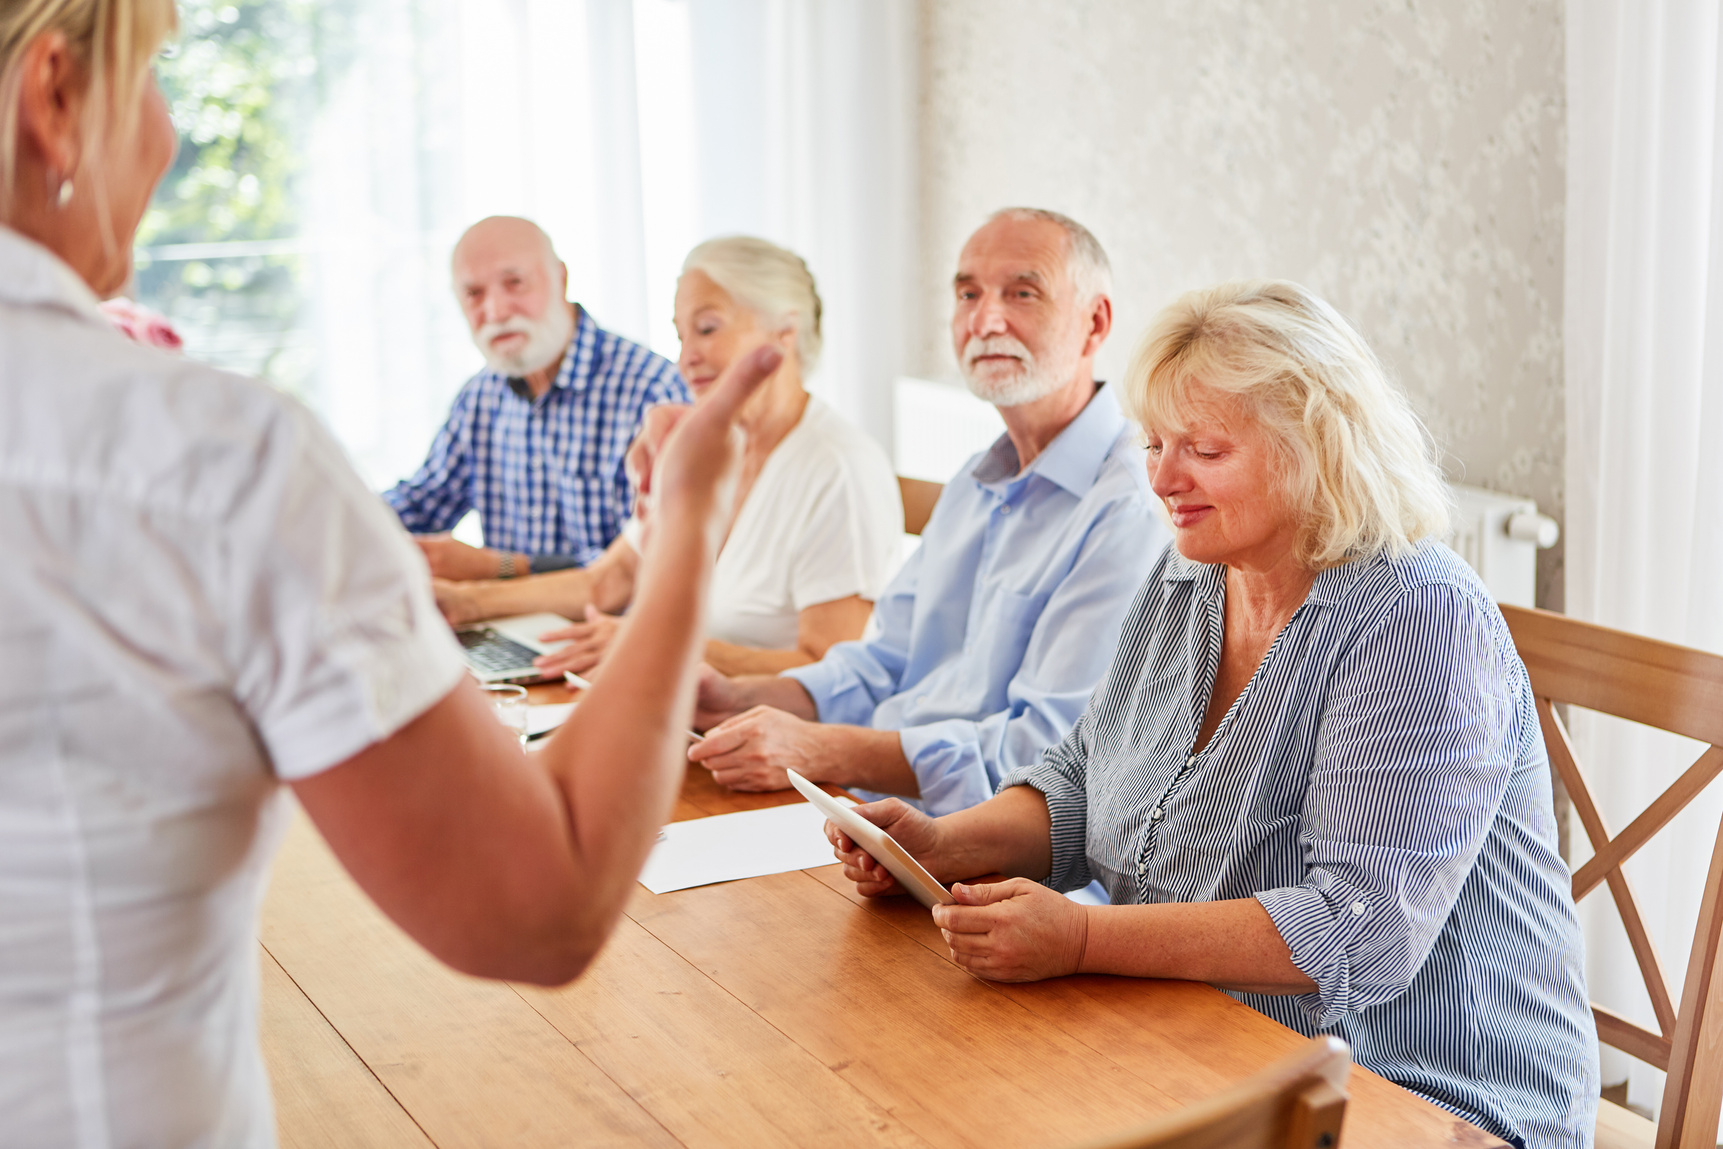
[305,0,648,486]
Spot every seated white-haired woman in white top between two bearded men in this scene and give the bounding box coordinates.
[436,236,903,674]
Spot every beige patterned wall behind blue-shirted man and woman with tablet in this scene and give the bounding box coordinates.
[915,0,1564,606]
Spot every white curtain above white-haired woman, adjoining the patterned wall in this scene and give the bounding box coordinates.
[691,0,917,450]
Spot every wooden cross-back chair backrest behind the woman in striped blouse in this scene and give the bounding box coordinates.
[1501,606,1723,1149]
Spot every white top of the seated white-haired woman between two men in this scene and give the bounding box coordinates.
[624,396,903,649]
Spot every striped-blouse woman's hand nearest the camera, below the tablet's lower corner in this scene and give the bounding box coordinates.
[937,875,1089,982]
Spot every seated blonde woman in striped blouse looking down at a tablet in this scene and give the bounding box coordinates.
[827,283,1597,1146]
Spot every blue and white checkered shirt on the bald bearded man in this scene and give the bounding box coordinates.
[383,308,689,567]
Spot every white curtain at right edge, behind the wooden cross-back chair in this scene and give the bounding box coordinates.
[1564,0,1723,1108]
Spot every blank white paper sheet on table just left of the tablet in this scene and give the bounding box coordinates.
[641,798,855,894]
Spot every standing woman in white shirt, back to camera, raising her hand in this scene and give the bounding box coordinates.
[0,0,777,1146]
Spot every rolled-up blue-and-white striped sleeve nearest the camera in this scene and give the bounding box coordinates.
[1256,584,1518,1025]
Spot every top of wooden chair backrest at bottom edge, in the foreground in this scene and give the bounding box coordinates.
[1084,1037,1353,1149]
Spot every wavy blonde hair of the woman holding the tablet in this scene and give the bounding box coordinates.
[1122,281,1449,568]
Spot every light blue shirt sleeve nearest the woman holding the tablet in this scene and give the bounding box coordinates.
[901,501,1166,817]
